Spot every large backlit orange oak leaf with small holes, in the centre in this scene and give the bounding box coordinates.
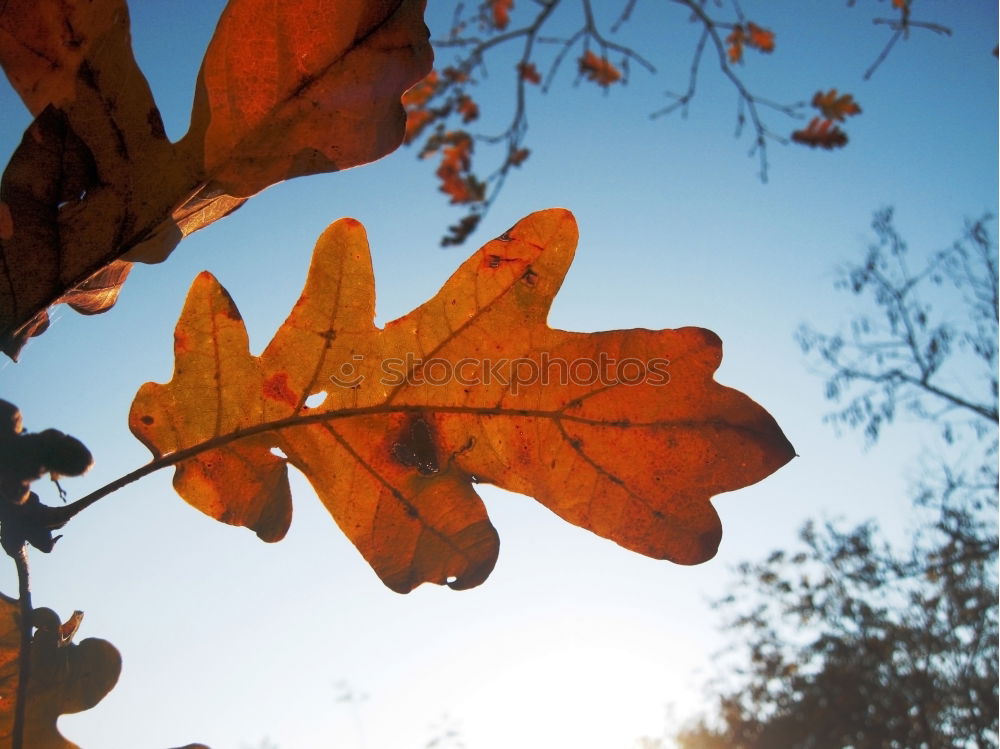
[129,209,793,592]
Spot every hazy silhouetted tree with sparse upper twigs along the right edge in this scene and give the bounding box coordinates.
[675,210,998,749]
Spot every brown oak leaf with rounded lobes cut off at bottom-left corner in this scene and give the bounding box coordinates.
[0,594,121,749]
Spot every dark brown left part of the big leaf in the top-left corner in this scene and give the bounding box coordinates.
[0,0,193,356]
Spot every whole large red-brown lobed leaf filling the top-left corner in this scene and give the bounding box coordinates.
[0,0,431,358]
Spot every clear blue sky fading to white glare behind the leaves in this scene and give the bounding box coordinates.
[0,0,997,749]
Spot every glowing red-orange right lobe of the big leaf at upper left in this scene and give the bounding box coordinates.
[181,0,431,197]
